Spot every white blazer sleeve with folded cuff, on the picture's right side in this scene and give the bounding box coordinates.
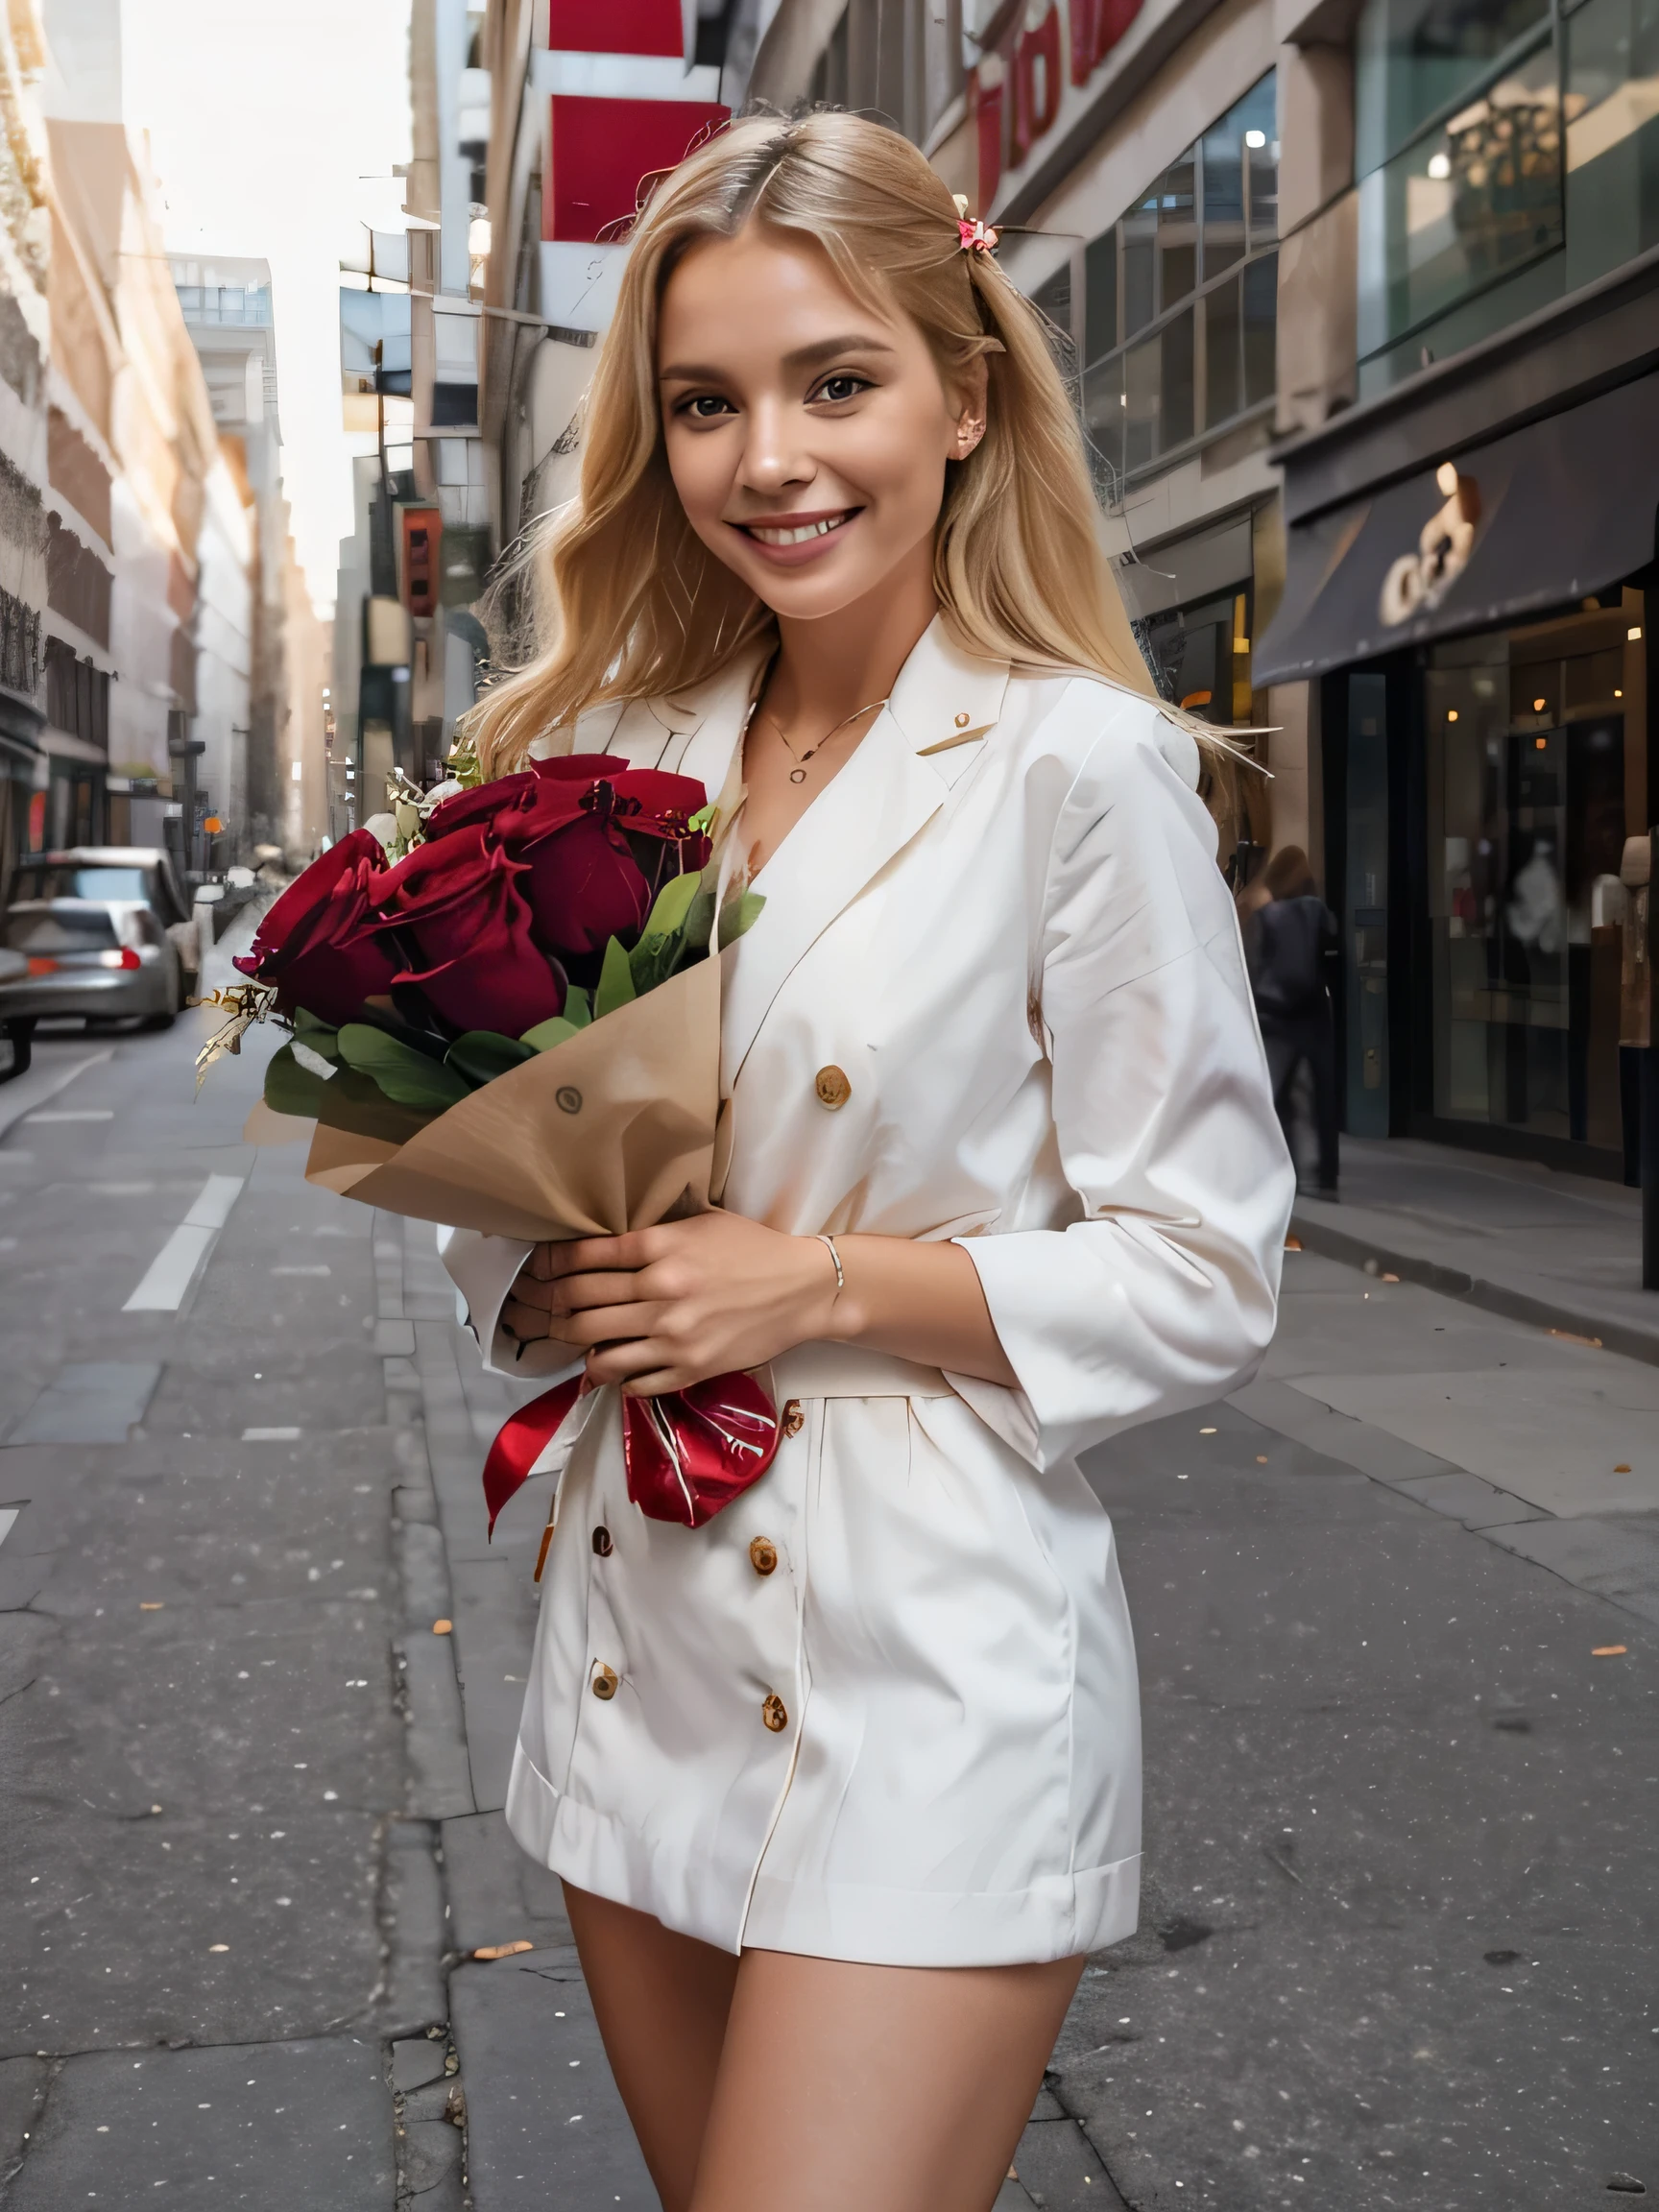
[951,690,1294,1467]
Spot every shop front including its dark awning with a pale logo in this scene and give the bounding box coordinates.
[1261,378,1659,1179]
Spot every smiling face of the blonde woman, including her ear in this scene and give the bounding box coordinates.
[657,224,984,621]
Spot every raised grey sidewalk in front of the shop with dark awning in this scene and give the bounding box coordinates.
[1292,1137,1659,1365]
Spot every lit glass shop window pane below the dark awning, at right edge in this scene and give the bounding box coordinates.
[1425,589,1646,1152]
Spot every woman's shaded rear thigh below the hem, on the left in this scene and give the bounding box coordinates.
[565,1883,736,2212]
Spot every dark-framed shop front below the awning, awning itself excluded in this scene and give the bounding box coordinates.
[1320,587,1647,1177]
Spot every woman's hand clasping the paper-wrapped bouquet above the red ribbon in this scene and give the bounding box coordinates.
[502,1210,836,1398]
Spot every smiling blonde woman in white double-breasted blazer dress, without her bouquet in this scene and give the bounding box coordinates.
[435,115,1289,2212]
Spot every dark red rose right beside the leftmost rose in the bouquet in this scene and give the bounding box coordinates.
[376,823,565,1038]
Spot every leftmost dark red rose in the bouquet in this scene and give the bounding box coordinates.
[232,830,400,1024]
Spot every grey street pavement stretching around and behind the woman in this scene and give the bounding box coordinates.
[0,955,1659,2212]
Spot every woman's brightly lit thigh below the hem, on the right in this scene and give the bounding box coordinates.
[692,1951,1084,2212]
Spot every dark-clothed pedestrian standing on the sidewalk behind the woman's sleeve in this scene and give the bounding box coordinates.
[1245,845,1336,1199]
